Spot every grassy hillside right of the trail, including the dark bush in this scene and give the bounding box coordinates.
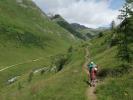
[89,32,133,100]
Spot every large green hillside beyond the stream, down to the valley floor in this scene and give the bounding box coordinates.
[0,0,75,91]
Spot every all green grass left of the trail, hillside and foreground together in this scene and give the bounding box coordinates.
[0,0,87,100]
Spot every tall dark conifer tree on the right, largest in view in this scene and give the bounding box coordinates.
[118,3,131,62]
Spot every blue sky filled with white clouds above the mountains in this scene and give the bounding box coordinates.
[33,0,124,28]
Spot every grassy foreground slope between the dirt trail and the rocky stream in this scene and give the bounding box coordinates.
[0,45,87,100]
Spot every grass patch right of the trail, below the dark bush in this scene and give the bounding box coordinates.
[97,73,133,100]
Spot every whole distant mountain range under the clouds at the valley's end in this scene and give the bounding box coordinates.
[50,14,104,40]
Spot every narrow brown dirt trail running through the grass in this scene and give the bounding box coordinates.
[83,48,97,100]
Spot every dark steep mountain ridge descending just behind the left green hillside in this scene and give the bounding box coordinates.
[51,14,85,40]
